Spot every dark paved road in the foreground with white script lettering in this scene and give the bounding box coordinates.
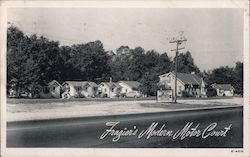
[7,107,243,148]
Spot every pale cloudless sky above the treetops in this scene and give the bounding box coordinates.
[7,8,243,70]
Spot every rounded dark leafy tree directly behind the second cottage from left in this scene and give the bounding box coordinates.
[68,40,110,81]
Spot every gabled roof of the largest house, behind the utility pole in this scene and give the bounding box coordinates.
[159,72,206,85]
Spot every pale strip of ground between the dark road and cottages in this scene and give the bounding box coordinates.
[7,97,243,121]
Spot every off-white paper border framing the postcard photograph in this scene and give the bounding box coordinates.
[0,0,250,157]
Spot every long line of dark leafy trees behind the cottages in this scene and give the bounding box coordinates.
[7,26,243,96]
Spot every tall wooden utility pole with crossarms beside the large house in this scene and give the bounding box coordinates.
[169,39,187,103]
